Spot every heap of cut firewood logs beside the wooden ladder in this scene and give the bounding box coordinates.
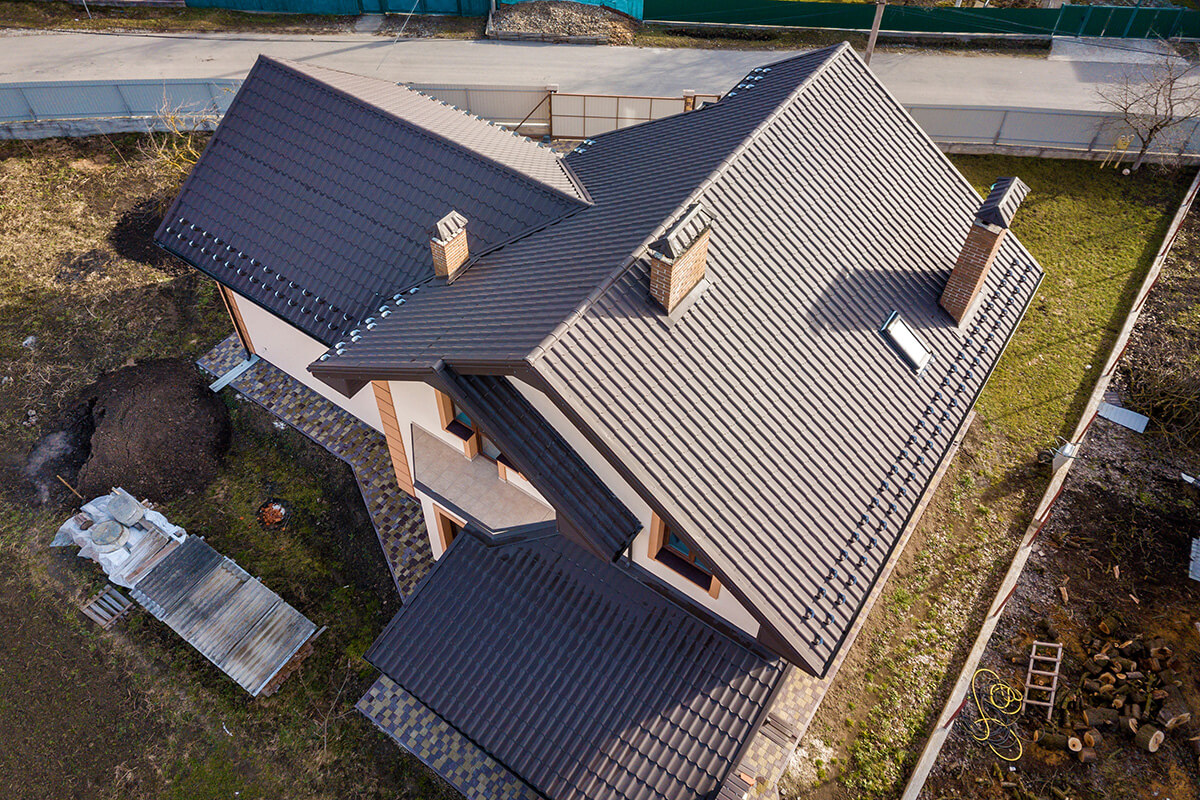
[1033,616,1200,764]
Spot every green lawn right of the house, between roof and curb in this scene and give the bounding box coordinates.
[954,156,1190,444]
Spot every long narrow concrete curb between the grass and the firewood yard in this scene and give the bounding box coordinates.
[901,167,1200,800]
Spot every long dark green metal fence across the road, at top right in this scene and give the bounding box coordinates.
[646,0,1200,38]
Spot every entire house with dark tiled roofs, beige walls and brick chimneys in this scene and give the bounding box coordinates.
[157,44,1042,800]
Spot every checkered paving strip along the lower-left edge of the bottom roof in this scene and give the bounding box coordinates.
[356,675,541,800]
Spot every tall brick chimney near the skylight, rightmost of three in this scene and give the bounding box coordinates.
[941,178,1030,326]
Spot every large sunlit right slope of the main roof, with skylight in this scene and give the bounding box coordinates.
[533,48,1042,673]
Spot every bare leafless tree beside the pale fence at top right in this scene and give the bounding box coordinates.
[1097,56,1200,169]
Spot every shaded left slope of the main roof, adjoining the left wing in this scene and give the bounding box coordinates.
[313,48,833,377]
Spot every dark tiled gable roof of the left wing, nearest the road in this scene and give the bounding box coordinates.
[155,56,587,344]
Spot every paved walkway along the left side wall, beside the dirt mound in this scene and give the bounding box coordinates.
[197,335,433,600]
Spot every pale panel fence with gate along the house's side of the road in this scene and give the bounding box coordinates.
[0,80,1200,160]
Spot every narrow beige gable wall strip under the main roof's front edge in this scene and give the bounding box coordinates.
[509,378,758,636]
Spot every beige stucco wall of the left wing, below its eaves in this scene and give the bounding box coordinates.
[234,294,383,432]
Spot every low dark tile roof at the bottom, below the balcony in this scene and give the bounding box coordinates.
[367,534,784,800]
